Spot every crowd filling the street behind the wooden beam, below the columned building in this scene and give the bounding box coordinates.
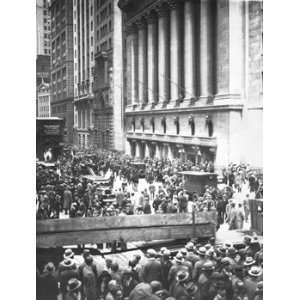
[36,148,262,229]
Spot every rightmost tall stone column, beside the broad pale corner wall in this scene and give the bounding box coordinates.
[199,0,213,97]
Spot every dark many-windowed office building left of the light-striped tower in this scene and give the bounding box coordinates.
[50,0,74,143]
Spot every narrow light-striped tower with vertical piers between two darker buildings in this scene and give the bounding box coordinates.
[73,0,95,148]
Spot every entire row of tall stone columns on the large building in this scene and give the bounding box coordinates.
[126,0,212,104]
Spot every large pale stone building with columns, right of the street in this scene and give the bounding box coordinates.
[118,0,263,168]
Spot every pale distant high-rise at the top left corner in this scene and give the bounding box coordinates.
[36,0,51,55]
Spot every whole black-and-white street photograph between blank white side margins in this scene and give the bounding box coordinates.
[34,0,264,300]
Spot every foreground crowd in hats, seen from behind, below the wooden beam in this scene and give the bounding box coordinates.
[37,236,263,300]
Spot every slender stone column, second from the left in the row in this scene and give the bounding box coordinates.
[137,19,148,104]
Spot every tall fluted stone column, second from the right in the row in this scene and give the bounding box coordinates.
[184,0,196,99]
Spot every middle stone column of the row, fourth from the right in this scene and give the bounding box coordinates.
[157,6,170,103]
